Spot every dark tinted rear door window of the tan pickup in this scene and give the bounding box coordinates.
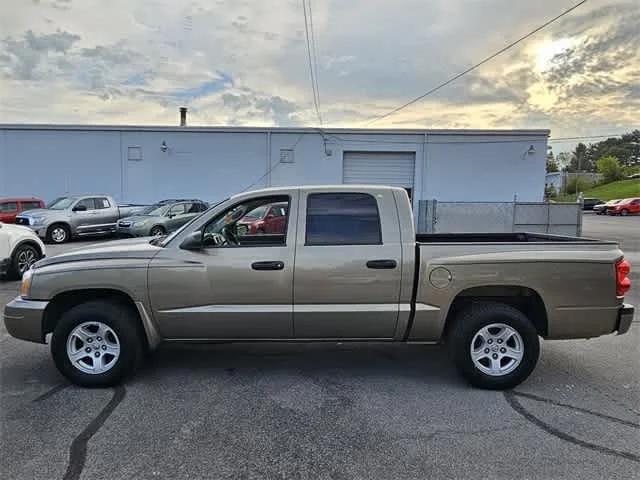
[306,193,382,245]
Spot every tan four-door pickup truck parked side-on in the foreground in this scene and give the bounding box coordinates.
[4,185,633,389]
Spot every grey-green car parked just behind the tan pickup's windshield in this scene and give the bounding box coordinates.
[116,200,208,237]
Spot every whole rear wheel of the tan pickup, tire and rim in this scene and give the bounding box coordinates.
[448,302,540,390]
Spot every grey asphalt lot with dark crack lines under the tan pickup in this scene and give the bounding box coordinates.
[0,215,640,480]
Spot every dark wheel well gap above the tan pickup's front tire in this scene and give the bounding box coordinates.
[43,288,148,348]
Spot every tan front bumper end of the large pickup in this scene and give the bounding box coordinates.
[4,297,49,343]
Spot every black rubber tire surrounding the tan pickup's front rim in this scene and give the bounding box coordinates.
[51,300,144,387]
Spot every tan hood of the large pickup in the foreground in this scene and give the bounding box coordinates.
[36,237,162,268]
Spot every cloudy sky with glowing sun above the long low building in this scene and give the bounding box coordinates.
[0,0,640,144]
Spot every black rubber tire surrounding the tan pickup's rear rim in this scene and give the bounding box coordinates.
[447,302,540,390]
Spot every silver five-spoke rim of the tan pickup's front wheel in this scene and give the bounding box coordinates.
[67,322,120,375]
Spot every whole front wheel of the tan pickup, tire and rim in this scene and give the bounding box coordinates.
[51,300,144,387]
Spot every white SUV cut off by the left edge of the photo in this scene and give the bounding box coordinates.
[0,222,46,278]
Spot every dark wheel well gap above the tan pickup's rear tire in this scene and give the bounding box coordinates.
[444,285,549,337]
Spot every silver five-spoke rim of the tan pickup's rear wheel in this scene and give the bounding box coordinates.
[470,323,524,377]
